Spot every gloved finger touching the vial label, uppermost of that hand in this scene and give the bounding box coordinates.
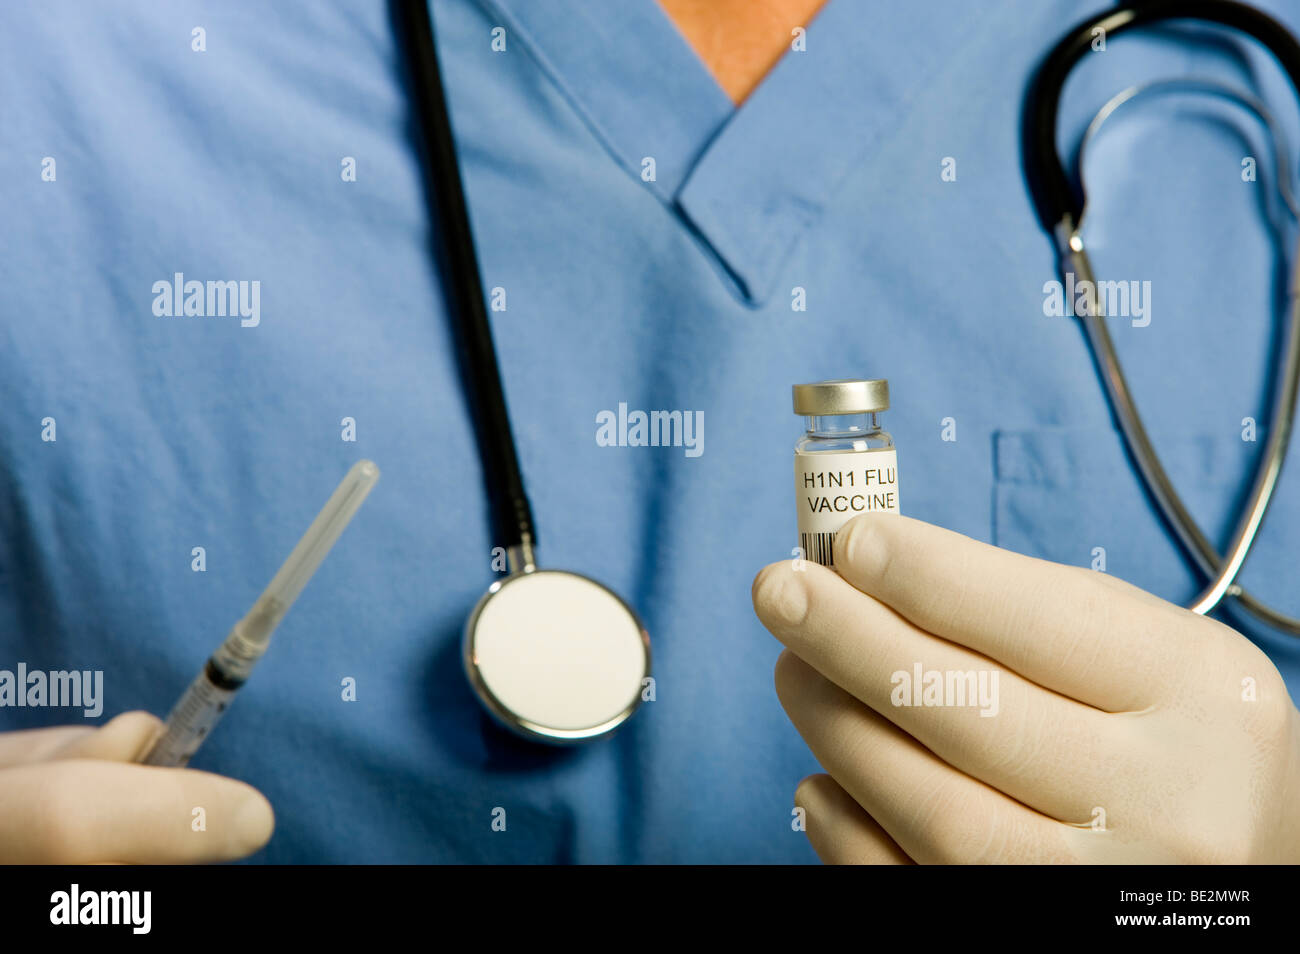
[835,515,1209,712]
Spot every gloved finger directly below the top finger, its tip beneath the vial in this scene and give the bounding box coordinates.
[754,563,1127,820]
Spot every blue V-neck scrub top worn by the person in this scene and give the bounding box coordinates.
[0,0,1300,862]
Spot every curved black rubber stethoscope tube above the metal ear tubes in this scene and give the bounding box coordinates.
[1022,0,1300,233]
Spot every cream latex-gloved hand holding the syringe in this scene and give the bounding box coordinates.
[0,712,274,864]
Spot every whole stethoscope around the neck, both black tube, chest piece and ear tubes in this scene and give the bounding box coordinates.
[397,0,1300,743]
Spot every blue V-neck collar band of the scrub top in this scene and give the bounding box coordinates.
[480,0,972,305]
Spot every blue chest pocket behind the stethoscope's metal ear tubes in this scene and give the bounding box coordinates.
[992,428,1300,698]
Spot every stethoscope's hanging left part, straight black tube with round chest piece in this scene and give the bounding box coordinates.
[397,0,650,743]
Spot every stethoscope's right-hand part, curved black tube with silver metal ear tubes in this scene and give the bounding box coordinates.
[1023,0,1300,636]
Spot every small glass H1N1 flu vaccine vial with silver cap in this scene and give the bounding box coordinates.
[794,381,898,567]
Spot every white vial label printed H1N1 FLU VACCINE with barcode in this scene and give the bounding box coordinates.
[794,447,900,567]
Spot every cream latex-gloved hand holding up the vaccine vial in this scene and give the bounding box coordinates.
[754,515,1300,863]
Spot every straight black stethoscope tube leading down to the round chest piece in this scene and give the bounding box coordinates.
[394,0,537,550]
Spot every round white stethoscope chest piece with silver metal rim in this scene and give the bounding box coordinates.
[464,569,650,745]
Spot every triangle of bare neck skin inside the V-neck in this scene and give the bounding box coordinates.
[659,0,826,105]
